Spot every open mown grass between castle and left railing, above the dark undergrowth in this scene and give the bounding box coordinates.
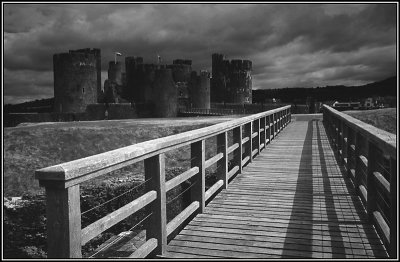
[3,117,239,196]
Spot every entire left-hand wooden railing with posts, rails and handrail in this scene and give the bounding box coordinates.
[35,106,291,258]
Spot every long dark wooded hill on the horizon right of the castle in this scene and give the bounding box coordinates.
[253,76,397,103]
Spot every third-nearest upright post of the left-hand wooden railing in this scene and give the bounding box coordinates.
[190,140,206,213]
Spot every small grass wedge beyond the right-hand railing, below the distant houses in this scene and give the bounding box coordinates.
[343,108,397,134]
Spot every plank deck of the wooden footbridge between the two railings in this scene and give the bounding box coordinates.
[163,120,387,259]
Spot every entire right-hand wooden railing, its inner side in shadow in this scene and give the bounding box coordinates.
[323,105,398,258]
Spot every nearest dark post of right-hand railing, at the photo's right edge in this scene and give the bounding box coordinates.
[389,157,398,258]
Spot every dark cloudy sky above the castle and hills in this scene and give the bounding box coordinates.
[3,2,397,103]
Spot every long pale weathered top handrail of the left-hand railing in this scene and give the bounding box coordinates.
[35,105,291,186]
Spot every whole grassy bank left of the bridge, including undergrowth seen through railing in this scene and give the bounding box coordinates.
[3,117,238,258]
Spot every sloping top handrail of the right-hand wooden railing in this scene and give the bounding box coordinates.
[323,105,397,157]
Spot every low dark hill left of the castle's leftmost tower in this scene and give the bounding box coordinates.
[4,97,54,113]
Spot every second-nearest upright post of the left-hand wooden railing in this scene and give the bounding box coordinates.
[144,153,167,256]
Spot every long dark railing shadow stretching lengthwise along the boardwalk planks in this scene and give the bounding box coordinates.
[282,120,346,258]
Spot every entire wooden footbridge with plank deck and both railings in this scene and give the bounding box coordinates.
[36,106,398,259]
